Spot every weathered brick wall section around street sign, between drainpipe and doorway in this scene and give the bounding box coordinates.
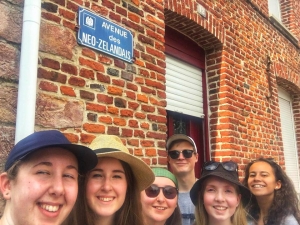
[36,0,167,164]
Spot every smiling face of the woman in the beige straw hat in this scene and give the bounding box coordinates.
[86,157,127,220]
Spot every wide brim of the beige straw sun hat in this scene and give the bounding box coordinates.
[94,148,155,191]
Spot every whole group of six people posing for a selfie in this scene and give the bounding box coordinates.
[0,130,300,225]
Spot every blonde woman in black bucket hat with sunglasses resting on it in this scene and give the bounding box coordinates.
[190,161,251,225]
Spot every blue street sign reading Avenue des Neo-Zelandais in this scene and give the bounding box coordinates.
[77,7,133,63]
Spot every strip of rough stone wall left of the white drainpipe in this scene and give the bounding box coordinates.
[0,0,23,169]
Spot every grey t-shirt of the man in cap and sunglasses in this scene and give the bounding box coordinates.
[178,192,195,225]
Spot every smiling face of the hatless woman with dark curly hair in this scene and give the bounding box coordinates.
[247,161,281,201]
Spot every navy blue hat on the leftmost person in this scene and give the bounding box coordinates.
[5,130,98,173]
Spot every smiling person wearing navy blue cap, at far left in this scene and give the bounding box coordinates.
[0,130,97,225]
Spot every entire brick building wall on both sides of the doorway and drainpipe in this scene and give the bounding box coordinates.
[0,0,300,176]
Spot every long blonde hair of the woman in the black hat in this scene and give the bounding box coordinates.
[195,178,247,225]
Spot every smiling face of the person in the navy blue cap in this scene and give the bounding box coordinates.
[1,147,78,225]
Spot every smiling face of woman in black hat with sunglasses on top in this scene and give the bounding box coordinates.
[203,176,241,224]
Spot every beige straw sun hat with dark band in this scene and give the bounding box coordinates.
[89,134,155,191]
